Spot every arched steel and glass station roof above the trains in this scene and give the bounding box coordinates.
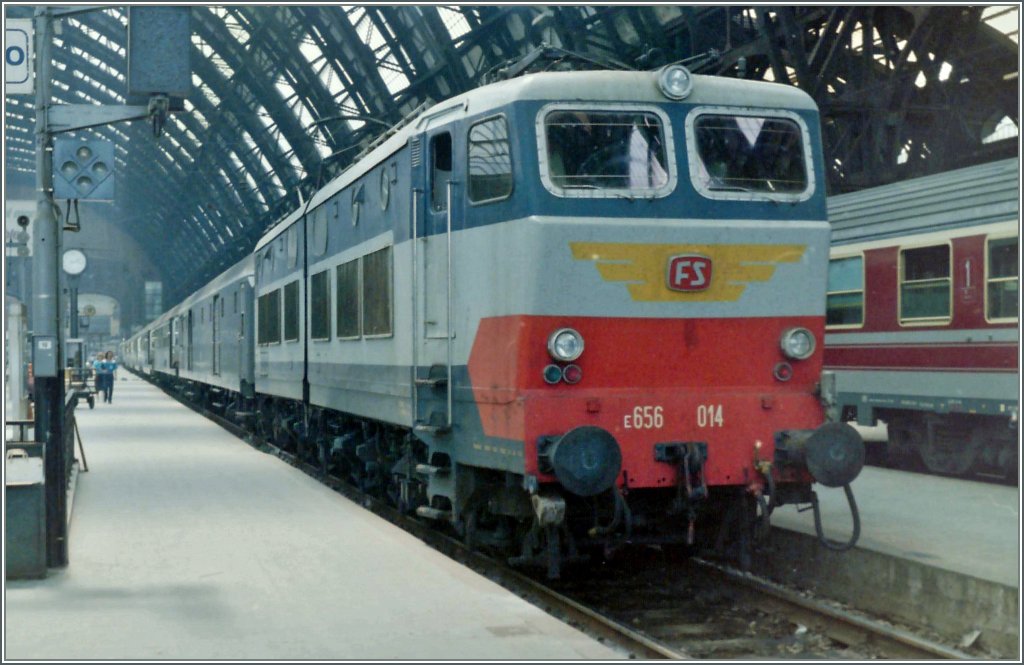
[4,4,1020,301]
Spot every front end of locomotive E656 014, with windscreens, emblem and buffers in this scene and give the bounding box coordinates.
[468,68,863,573]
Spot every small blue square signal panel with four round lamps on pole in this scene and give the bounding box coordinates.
[53,137,114,201]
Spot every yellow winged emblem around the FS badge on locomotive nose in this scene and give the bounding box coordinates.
[569,243,807,302]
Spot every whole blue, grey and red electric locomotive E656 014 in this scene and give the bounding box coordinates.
[128,66,863,576]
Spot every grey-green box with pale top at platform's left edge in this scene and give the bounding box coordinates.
[4,448,46,580]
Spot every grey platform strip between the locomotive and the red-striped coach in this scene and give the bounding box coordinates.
[772,456,1021,589]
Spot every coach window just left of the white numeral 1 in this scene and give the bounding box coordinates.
[899,245,952,323]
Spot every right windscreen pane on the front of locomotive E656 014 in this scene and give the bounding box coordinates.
[690,114,808,194]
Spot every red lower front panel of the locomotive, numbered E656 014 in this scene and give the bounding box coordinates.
[469,317,823,488]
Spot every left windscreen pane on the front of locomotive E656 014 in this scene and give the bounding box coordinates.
[544,109,671,197]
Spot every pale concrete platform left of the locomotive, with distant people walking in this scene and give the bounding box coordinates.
[4,372,626,661]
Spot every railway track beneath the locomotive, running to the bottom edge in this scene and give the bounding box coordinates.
[157,372,976,660]
